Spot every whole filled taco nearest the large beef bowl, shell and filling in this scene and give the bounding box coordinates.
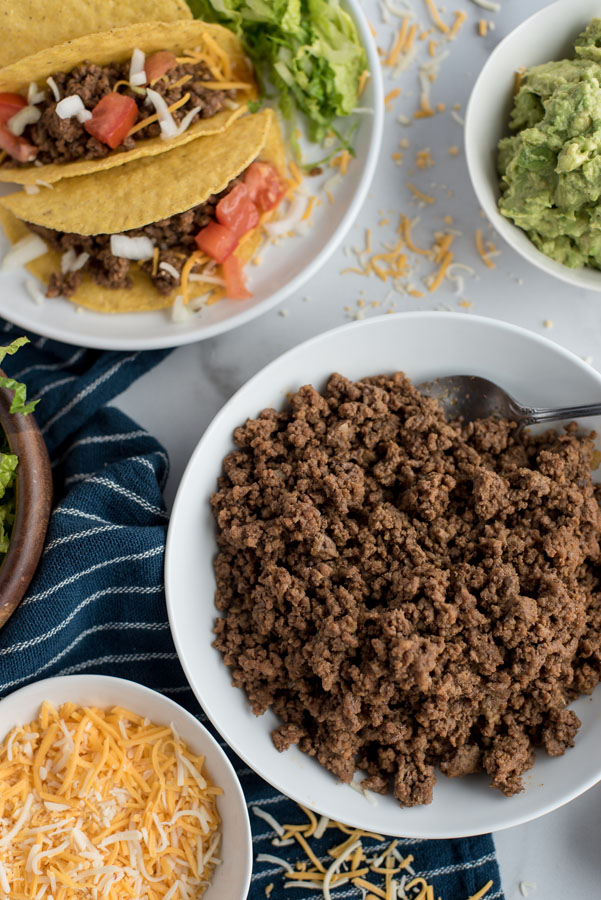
[0,110,287,313]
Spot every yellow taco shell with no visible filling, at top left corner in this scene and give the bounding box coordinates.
[0,0,192,66]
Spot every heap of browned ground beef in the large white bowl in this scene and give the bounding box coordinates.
[211,374,601,806]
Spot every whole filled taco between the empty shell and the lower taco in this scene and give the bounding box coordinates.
[0,21,256,185]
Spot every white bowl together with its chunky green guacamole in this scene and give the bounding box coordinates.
[465,0,601,291]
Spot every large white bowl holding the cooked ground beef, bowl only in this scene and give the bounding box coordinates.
[165,312,601,838]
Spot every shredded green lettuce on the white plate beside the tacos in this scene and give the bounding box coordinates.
[188,0,367,149]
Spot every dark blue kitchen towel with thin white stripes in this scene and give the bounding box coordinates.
[0,322,503,900]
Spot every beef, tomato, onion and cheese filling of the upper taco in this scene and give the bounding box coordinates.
[0,49,250,167]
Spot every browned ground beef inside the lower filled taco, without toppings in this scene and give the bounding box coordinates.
[27,177,240,297]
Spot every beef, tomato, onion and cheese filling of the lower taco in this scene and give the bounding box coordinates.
[27,161,286,299]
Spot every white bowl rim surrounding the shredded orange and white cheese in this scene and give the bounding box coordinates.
[0,675,252,900]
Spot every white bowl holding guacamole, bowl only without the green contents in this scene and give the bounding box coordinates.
[465,0,601,291]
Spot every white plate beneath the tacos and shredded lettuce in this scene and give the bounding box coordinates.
[0,0,384,350]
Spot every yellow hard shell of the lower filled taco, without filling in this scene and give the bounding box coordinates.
[0,110,285,313]
